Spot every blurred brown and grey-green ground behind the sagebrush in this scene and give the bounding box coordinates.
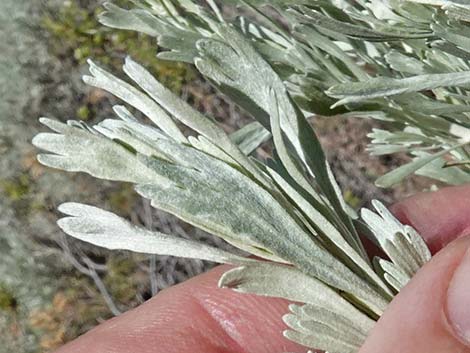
[0,0,427,353]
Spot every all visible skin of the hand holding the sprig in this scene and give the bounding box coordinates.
[56,186,470,353]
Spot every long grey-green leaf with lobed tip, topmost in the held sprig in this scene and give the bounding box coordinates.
[196,25,352,236]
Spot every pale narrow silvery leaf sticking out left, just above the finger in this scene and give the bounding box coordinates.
[57,203,252,264]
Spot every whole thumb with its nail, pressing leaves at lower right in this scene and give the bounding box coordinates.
[360,237,470,353]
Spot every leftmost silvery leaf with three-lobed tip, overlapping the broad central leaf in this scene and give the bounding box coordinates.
[33,118,161,183]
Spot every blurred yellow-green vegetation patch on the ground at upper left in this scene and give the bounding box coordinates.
[42,1,195,94]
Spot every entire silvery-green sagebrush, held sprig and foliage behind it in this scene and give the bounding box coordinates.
[33,0,470,353]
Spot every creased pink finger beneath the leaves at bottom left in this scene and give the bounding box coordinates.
[57,266,306,353]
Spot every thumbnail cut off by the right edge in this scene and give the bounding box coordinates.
[447,250,470,345]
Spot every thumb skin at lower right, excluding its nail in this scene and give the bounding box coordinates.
[360,237,470,353]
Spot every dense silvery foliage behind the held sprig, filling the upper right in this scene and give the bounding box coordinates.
[100,0,470,187]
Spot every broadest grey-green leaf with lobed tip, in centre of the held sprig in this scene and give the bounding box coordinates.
[136,140,388,312]
